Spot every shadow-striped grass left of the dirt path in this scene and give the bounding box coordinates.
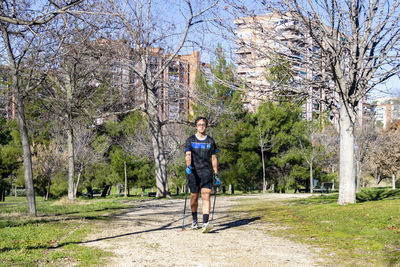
[0,197,127,266]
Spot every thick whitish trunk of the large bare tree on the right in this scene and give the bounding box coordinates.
[338,104,356,205]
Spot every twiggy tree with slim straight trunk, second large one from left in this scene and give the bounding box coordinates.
[39,6,117,201]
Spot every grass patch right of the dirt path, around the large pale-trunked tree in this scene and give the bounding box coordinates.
[237,189,400,266]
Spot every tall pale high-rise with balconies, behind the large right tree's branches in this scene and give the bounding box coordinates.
[234,13,337,121]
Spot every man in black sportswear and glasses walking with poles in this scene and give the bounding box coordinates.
[185,117,220,233]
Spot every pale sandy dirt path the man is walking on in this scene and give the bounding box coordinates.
[86,194,321,266]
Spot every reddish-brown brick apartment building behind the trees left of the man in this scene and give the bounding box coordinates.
[103,41,202,120]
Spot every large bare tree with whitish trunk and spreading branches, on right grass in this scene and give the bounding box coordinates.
[227,0,400,205]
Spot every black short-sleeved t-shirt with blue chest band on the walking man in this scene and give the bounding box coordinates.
[185,135,218,174]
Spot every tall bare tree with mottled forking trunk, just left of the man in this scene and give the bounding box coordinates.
[100,0,218,197]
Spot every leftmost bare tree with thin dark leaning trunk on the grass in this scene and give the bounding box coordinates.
[0,1,86,216]
